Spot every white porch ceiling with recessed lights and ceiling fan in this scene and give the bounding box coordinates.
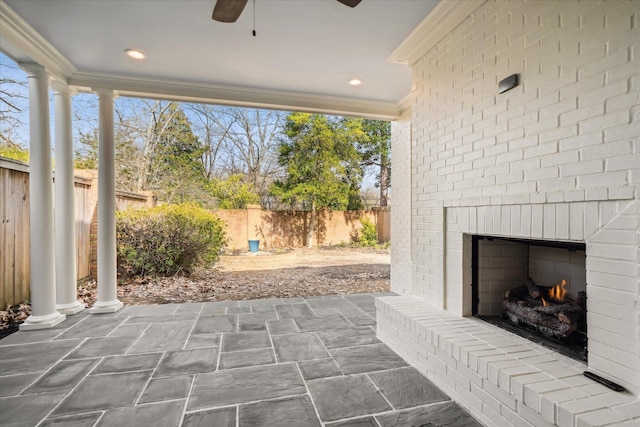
[0,0,438,116]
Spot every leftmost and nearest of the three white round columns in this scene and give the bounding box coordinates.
[20,63,66,330]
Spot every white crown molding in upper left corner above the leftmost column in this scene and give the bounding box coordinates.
[0,1,76,81]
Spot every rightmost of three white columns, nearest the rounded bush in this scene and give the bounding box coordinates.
[90,90,123,313]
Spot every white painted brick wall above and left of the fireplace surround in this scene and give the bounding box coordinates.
[404,0,640,307]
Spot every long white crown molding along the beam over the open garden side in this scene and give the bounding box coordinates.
[69,73,400,120]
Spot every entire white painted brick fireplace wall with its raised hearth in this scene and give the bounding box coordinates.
[377,0,640,427]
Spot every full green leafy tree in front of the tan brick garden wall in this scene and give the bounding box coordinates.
[271,113,363,247]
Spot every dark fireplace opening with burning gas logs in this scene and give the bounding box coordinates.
[471,235,587,362]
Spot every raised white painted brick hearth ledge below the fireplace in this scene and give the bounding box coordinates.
[376,296,640,427]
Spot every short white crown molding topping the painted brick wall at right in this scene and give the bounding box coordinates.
[387,0,487,65]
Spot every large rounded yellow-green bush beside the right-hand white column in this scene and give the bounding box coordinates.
[116,203,225,276]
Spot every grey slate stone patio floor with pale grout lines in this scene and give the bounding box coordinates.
[0,294,480,427]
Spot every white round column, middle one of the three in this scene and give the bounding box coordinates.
[51,81,84,314]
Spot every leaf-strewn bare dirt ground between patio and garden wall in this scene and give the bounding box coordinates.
[0,247,390,337]
